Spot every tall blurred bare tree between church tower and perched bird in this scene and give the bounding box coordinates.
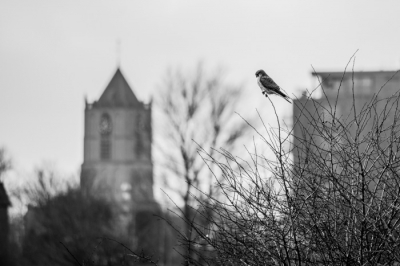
[158,64,247,261]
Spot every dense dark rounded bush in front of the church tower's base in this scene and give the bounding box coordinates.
[22,189,130,265]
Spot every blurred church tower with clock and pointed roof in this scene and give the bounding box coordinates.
[81,69,158,215]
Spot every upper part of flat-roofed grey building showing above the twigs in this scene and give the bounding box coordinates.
[293,71,400,164]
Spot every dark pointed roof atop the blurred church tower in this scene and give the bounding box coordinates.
[94,68,141,107]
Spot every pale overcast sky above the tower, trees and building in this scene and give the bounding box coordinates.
[0,0,400,181]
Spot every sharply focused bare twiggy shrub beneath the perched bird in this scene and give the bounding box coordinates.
[173,59,400,265]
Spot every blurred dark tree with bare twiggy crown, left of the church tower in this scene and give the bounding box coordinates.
[7,167,132,265]
